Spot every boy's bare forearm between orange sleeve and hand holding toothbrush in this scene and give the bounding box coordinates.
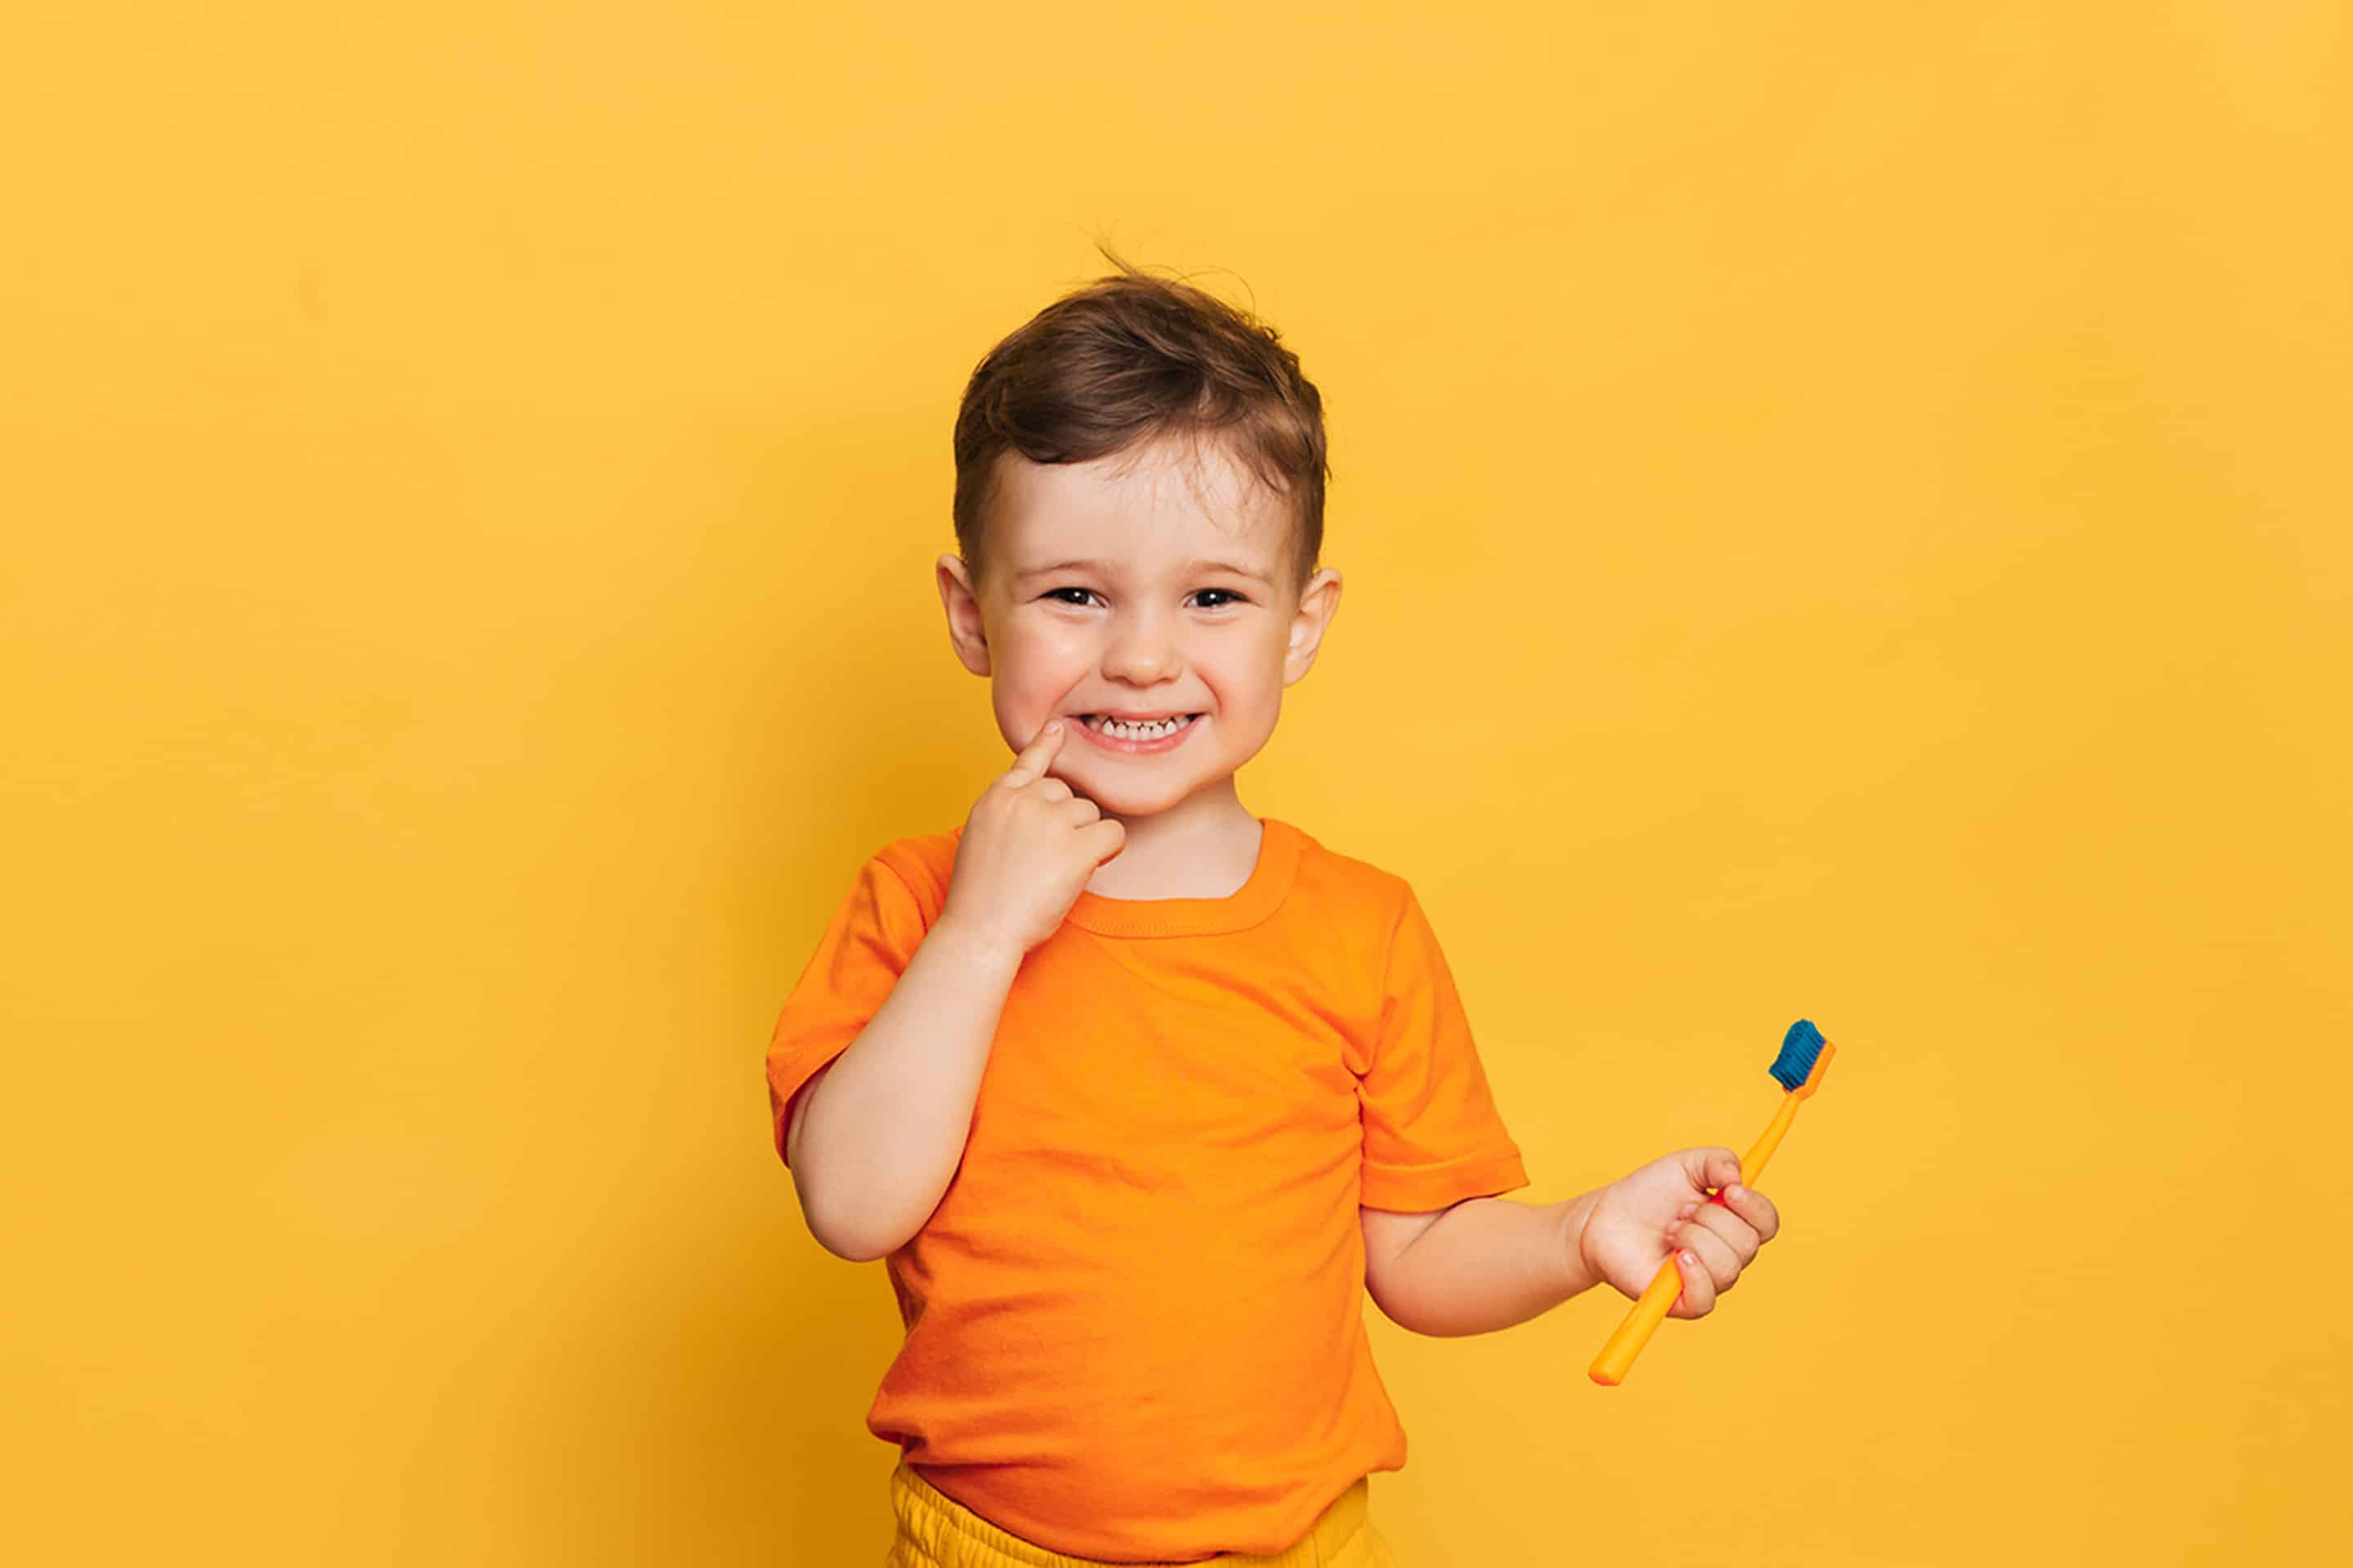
[1358,1189,1600,1335]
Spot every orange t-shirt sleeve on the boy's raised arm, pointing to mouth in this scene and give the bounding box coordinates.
[767,855,925,1161]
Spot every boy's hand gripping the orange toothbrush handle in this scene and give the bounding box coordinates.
[1577,1146,1781,1319]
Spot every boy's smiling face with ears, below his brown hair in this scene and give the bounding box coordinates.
[939,428,1342,817]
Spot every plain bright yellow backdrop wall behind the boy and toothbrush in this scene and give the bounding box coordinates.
[0,0,2353,1568]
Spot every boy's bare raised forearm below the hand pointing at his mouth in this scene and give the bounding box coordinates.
[786,921,1024,1262]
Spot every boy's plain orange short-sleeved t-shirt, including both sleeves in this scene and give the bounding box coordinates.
[767,817,1527,1561]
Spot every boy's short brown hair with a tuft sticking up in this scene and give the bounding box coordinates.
[953,240,1332,596]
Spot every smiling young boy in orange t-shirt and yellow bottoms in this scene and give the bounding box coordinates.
[767,257,1779,1568]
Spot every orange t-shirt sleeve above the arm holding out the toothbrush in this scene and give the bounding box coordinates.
[1358,887,1527,1213]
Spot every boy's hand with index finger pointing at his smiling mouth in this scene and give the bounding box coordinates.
[939,718,1127,954]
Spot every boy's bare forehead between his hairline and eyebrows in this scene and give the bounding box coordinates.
[993,447,1287,577]
